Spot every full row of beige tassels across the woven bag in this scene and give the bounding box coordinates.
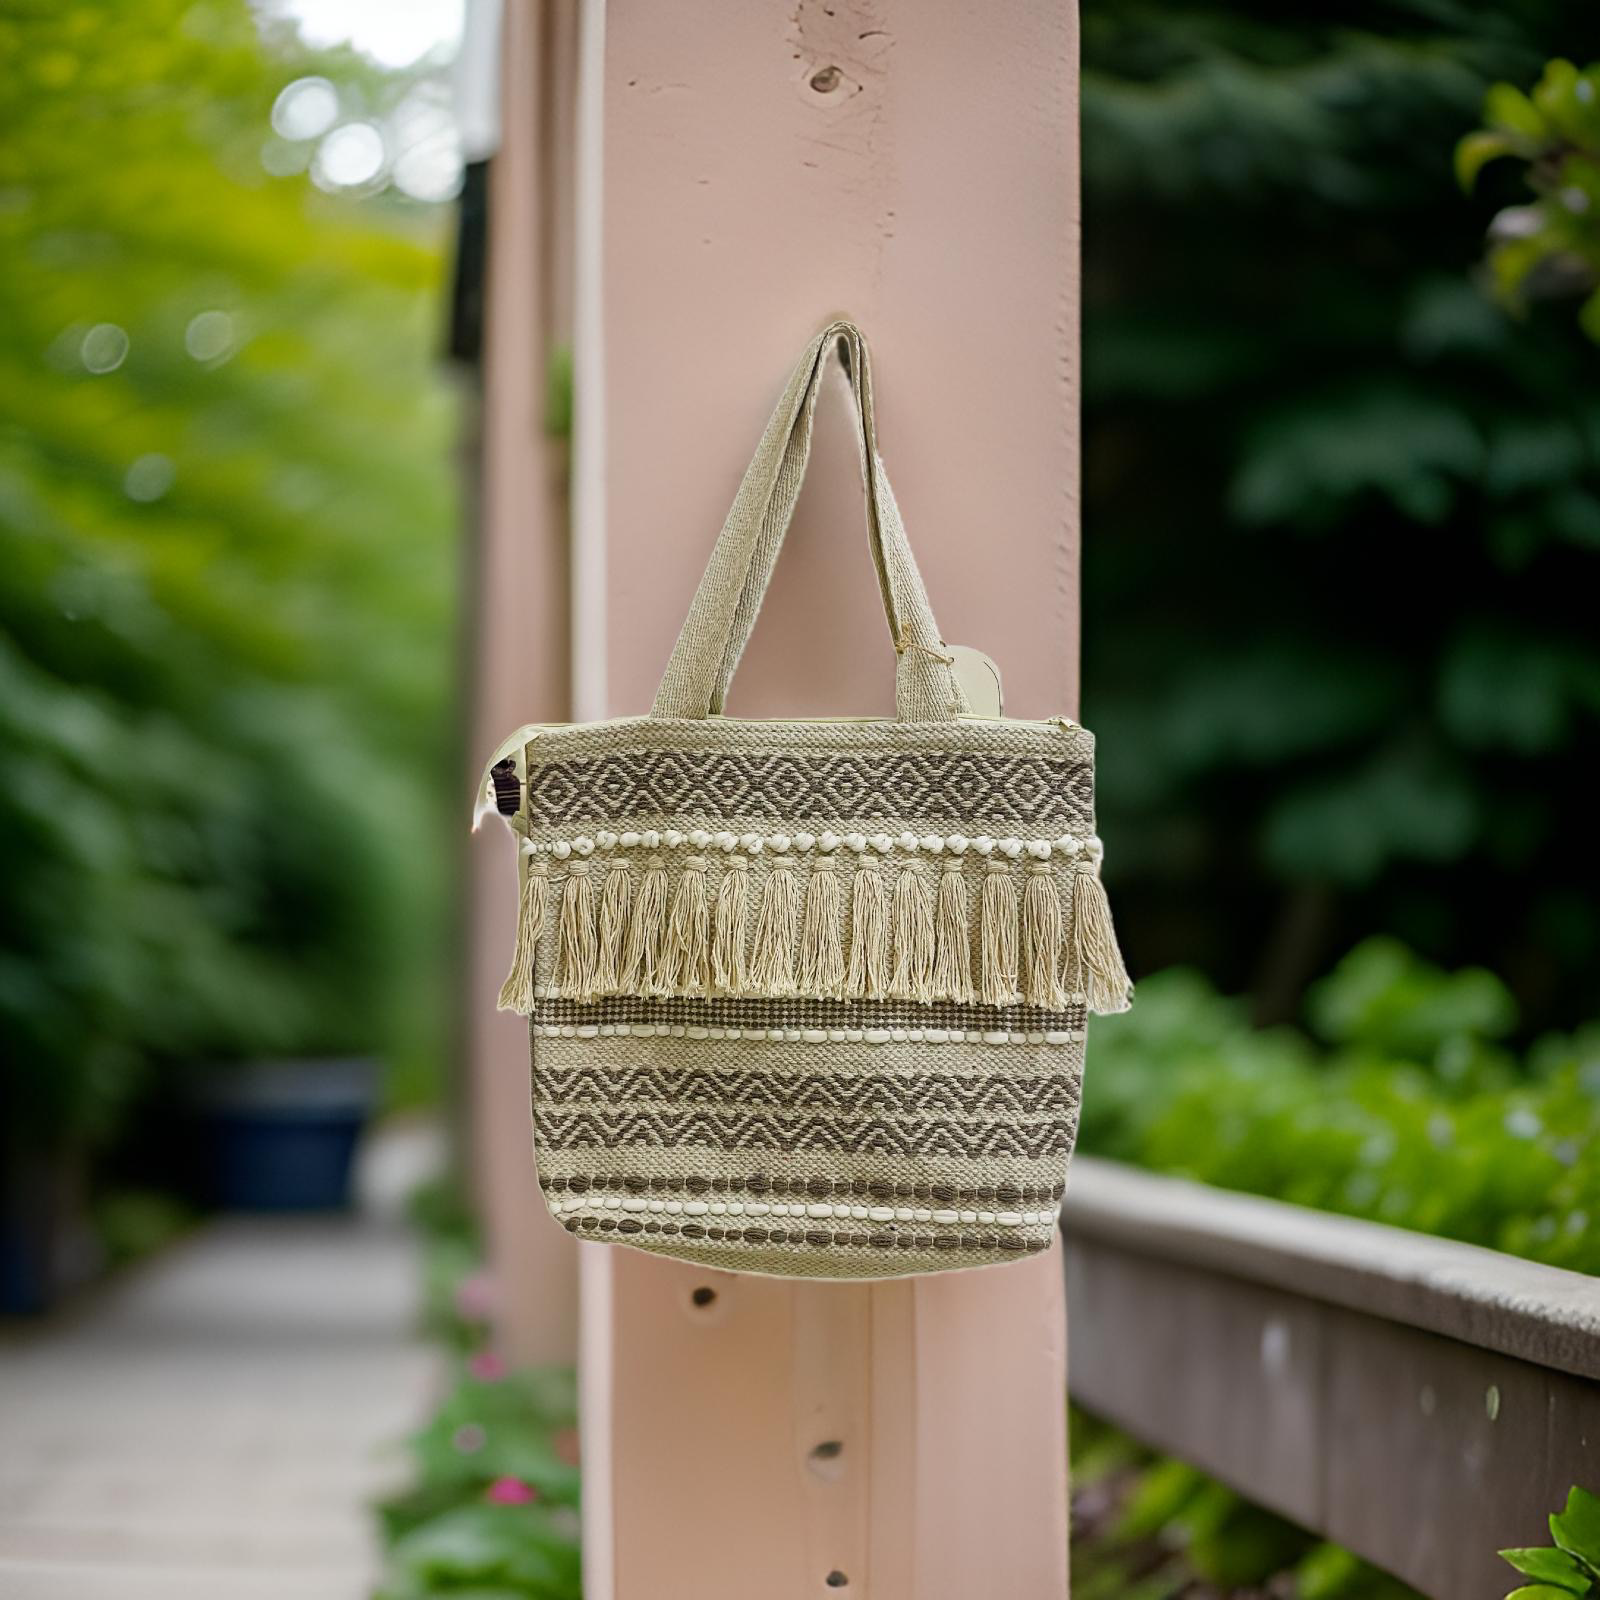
[499,835,1131,1016]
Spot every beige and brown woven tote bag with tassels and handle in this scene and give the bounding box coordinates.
[480,322,1128,1278]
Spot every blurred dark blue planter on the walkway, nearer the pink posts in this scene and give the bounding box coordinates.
[202,1061,378,1211]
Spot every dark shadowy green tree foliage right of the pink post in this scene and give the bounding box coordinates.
[1083,0,1600,1024]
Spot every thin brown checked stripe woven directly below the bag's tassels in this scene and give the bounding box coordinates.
[531,995,1086,1034]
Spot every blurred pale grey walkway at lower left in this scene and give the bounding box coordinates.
[0,1218,435,1600]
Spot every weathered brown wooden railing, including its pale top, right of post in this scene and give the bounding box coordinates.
[1062,1157,1600,1600]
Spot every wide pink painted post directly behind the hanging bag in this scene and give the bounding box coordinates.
[574,0,1078,1600]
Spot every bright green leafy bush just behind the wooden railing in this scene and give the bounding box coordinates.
[1082,939,1600,1272]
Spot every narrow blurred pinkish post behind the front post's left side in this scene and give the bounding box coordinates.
[462,0,578,1365]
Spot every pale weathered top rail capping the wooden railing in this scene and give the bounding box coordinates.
[1062,1155,1600,1379]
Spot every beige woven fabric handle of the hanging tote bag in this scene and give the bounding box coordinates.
[650,320,968,722]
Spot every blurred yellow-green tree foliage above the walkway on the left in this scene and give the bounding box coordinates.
[0,0,454,1146]
